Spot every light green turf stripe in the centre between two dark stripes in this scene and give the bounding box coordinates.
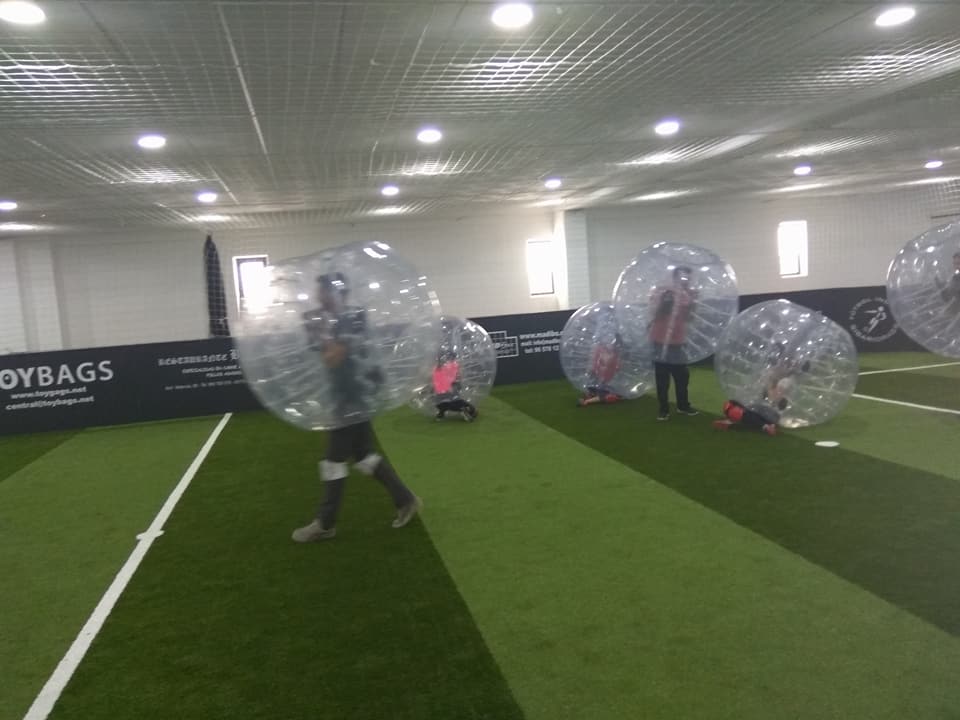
[380,400,960,720]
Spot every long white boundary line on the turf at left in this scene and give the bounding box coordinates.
[23,413,232,720]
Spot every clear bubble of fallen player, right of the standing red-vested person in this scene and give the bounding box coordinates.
[713,300,857,428]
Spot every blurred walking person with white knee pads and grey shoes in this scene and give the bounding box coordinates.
[293,272,423,543]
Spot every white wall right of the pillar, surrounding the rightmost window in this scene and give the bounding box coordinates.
[587,192,956,300]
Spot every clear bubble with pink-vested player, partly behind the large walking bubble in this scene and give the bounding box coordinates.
[410,316,497,416]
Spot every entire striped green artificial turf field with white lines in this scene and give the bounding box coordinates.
[0,353,960,720]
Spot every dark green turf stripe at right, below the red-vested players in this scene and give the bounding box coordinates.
[497,382,960,635]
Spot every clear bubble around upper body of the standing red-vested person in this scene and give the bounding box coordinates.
[613,243,739,365]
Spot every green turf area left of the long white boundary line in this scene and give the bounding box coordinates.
[0,420,221,720]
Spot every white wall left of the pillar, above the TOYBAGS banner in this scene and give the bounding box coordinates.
[16,213,558,351]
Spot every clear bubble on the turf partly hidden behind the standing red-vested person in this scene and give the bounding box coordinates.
[560,302,653,398]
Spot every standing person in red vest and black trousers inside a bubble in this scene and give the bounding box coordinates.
[650,265,698,420]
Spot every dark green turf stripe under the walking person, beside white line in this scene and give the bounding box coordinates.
[52,414,522,720]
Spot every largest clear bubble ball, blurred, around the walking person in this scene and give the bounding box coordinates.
[236,242,440,430]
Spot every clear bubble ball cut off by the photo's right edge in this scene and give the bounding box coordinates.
[887,222,960,358]
